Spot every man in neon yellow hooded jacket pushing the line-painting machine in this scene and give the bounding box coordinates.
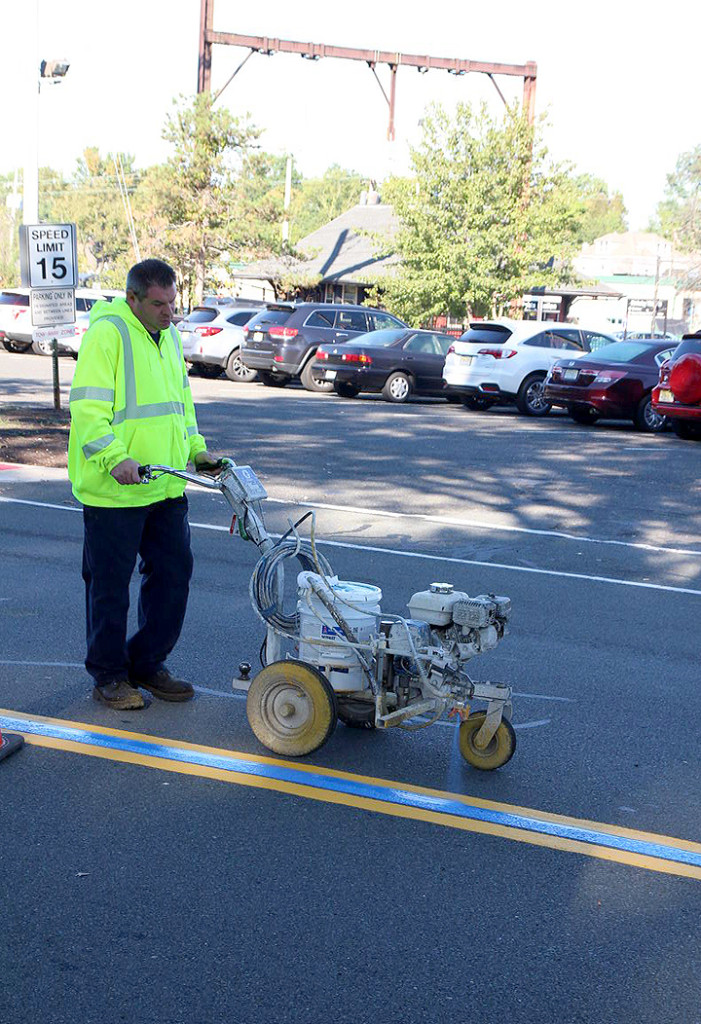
[69,259,218,711]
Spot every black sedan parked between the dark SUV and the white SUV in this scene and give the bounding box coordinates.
[314,328,453,402]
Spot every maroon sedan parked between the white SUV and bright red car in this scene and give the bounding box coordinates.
[544,339,675,432]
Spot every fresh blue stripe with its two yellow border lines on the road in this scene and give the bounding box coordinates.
[5,712,701,879]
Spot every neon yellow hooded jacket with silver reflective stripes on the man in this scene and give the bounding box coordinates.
[69,299,207,507]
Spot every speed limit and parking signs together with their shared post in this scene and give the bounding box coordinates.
[19,224,78,409]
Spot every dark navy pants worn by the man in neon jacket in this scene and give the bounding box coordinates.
[83,496,192,686]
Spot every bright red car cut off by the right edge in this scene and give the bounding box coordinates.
[652,331,701,440]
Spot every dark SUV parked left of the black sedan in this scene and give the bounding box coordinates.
[242,302,406,391]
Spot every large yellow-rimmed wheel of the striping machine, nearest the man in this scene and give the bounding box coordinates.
[246,658,338,757]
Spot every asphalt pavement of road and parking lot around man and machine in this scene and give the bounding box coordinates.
[0,351,701,1024]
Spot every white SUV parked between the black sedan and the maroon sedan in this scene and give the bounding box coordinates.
[443,318,615,416]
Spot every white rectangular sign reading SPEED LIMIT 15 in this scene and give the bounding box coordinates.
[19,224,78,289]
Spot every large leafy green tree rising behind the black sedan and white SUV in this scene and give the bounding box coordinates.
[374,104,581,325]
